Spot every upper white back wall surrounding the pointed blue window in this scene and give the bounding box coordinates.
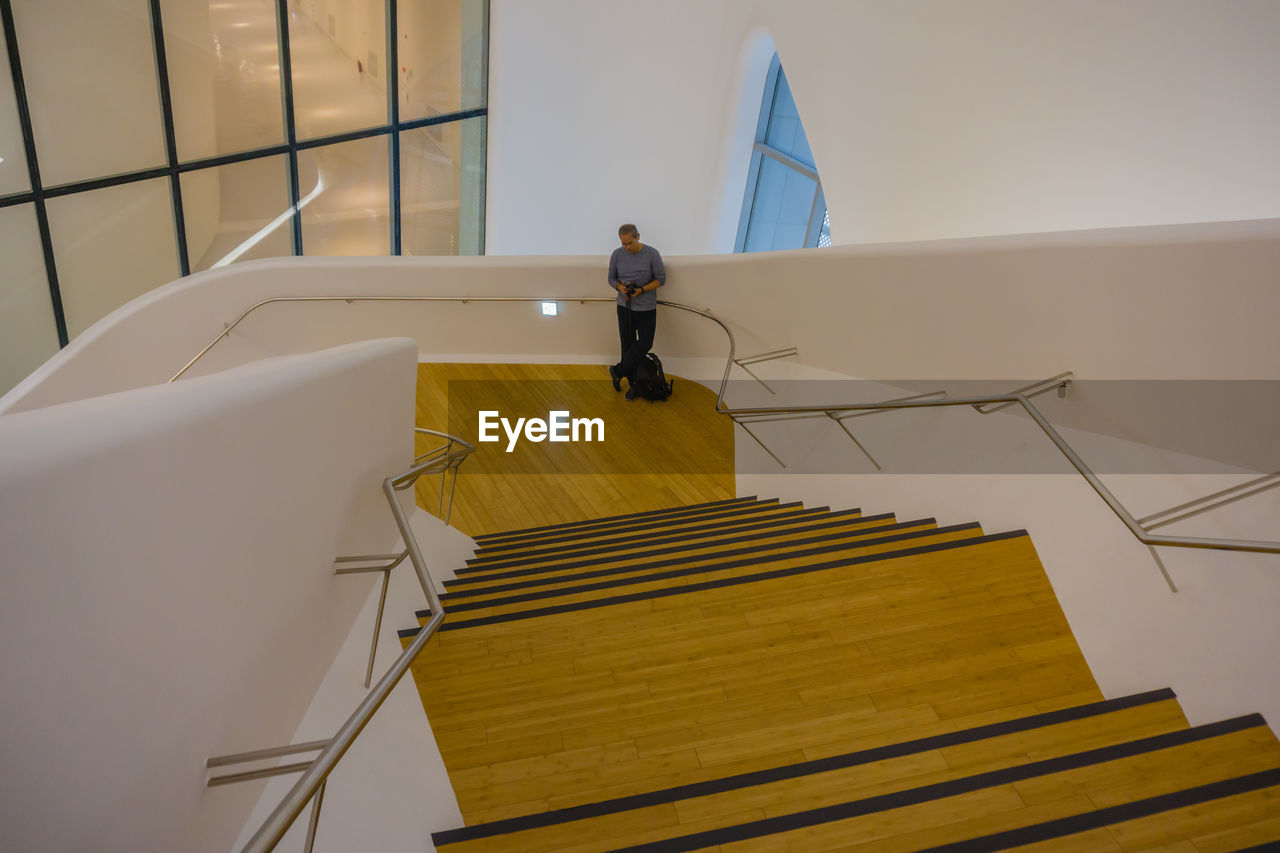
[488,0,1280,254]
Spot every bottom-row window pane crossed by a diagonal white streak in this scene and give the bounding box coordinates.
[182,155,291,273]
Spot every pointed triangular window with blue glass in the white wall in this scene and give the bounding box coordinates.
[735,54,831,252]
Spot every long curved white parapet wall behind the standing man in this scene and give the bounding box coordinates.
[0,219,1280,414]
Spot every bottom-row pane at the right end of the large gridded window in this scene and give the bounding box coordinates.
[401,117,485,255]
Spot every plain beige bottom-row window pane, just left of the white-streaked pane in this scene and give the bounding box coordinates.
[49,178,178,338]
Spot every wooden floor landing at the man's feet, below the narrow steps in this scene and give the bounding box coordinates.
[416,364,735,535]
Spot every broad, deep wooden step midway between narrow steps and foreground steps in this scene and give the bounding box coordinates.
[404,535,1101,822]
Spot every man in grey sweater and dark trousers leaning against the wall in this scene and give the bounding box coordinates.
[609,224,667,400]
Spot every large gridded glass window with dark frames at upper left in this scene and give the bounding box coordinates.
[0,0,489,356]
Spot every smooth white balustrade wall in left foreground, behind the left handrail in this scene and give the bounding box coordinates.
[0,341,415,850]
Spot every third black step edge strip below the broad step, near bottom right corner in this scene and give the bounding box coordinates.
[920,767,1280,853]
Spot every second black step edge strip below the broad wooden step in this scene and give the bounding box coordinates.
[613,713,1264,853]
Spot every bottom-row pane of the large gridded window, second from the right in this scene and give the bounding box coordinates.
[298,136,392,255]
